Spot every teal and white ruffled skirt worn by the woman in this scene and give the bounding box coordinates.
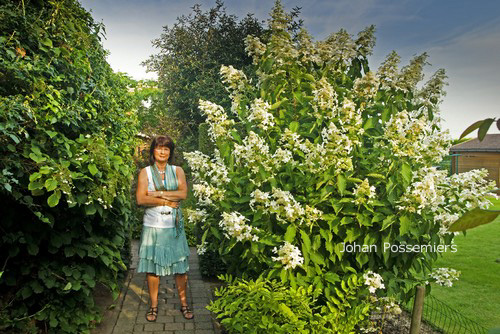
[137,226,189,276]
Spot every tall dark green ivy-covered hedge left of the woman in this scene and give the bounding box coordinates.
[0,0,138,333]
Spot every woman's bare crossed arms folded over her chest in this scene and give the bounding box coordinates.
[135,167,187,208]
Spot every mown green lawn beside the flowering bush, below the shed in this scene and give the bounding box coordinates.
[431,200,500,329]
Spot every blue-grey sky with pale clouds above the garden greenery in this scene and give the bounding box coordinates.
[80,0,500,138]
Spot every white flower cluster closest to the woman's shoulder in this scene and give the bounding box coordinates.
[184,151,230,186]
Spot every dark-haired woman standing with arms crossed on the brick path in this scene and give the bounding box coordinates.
[136,136,194,322]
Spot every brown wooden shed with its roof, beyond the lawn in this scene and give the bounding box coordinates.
[450,134,500,193]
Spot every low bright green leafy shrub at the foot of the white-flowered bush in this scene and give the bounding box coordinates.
[207,275,370,334]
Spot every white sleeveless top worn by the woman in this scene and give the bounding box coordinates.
[143,165,178,228]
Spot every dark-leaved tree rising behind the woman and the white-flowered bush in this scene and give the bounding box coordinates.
[145,0,301,148]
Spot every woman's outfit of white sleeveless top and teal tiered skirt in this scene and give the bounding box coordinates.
[137,164,189,276]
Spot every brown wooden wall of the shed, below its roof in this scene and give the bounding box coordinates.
[451,152,500,193]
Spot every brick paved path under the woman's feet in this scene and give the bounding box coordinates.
[108,242,220,334]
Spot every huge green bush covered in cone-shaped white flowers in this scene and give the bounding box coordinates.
[185,2,494,332]
